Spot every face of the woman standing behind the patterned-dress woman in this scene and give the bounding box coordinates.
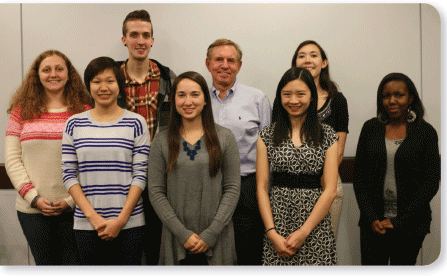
[296,44,328,79]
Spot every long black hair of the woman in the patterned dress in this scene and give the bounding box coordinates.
[272,67,323,147]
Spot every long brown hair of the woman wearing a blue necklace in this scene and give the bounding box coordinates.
[166,71,223,177]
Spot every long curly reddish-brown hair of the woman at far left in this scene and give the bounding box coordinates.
[7,50,93,120]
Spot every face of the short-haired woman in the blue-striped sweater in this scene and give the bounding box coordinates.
[90,69,120,108]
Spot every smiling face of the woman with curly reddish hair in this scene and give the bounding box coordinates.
[39,55,68,94]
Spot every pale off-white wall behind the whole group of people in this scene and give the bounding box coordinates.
[0,4,441,265]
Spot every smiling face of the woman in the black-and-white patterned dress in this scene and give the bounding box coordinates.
[281,79,312,118]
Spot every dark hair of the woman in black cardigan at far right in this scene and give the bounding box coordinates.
[377,72,425,121]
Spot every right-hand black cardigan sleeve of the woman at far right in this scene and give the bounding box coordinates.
[391,126,441,228]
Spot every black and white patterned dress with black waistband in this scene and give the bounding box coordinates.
[260,124,338,265]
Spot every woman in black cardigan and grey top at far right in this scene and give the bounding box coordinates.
[354,73,441,265]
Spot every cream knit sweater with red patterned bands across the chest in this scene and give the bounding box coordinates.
[5,105,91,213]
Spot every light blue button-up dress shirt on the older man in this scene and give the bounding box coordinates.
[210,80,272,176]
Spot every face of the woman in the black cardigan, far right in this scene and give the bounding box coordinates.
[382,80,413,121]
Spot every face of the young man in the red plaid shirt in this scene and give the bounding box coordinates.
[121,20,154,60]
